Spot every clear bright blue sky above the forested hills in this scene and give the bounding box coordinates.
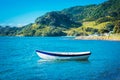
[0,0,106,26]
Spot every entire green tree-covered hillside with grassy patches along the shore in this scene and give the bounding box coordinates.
[0,0,120,36]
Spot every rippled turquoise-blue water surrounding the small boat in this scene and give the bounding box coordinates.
[0,37,120,80]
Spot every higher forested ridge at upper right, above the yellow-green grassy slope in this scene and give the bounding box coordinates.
[61,0,120,21]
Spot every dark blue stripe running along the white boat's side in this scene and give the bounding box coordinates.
[36,50,91,57]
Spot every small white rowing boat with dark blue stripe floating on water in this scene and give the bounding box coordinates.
[36,51,91,60]
